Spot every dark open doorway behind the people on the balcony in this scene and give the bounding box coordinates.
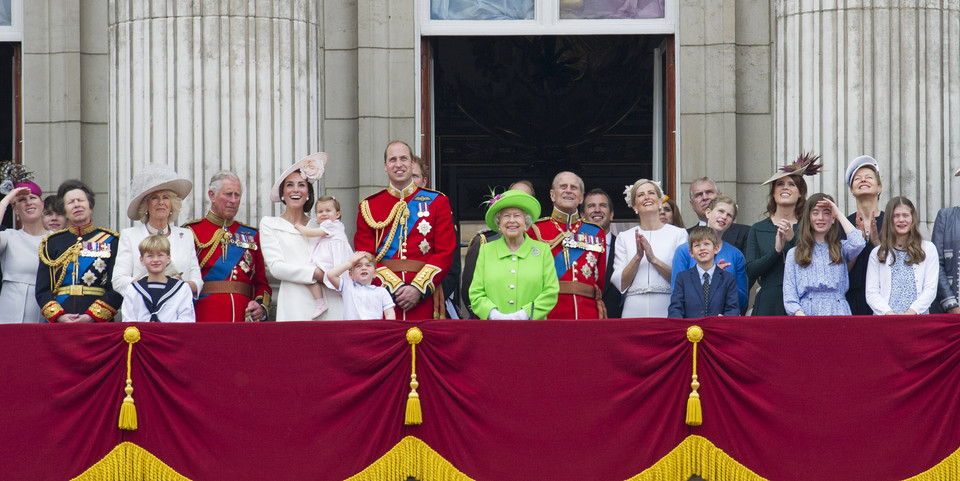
[424,35,674,225]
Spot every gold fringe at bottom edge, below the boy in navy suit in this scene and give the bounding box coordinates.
[627,436,766,481]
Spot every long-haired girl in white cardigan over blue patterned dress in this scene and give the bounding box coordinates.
[865,197,940,315]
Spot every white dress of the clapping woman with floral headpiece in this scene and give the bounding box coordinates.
[610,224,687,318]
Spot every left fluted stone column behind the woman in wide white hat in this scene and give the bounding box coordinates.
[108,0,323,228]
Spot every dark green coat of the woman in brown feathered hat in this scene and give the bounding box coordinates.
[743,217,799,316]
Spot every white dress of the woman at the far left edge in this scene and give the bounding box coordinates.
[0,229,46,324]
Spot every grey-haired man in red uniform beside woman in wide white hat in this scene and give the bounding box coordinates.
[184,170,272,322]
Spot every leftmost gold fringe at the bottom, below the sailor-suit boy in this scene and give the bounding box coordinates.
[73,442,190,481]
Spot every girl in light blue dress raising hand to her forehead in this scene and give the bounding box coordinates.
[783,194,866,316]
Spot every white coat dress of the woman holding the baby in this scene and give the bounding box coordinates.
[260,217,343,321]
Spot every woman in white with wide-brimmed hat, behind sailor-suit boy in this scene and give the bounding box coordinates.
[111,164,203,299]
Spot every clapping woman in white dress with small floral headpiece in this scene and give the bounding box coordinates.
[610,179,687,318]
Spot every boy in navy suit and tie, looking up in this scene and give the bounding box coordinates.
[667,226,740,318]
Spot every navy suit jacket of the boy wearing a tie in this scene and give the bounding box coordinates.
[667,266,740,318]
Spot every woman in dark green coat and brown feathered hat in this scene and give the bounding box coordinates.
[743,153,822,316]
